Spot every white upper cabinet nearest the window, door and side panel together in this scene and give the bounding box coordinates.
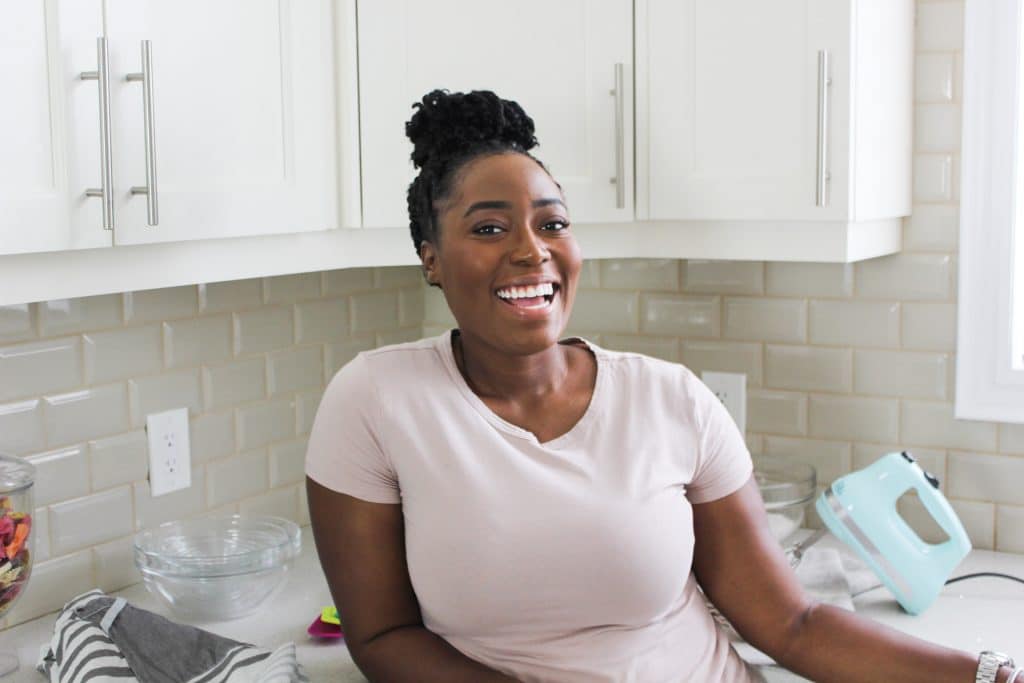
[637,0,913,260]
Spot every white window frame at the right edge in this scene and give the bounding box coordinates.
[955,0,1024,423]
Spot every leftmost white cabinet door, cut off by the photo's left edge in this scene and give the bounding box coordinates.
[0,0,111,254]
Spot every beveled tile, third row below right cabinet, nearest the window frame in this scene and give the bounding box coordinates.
[853,350,952,400]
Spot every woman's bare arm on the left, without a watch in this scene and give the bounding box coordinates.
[306,477,515,683]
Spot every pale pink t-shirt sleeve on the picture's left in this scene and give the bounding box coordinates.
[306,355,401,503]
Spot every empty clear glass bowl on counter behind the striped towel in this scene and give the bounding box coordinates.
[134,515,301,621]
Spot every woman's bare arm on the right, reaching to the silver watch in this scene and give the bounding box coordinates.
[693,478,1010,683]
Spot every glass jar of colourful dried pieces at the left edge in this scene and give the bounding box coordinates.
[0,454,36,676]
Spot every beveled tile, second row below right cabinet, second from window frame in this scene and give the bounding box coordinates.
[809,300,900,347]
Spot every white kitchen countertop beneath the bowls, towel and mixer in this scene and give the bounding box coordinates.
[0,526,1024,683]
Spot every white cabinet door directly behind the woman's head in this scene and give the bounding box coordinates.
[358,0,633,227]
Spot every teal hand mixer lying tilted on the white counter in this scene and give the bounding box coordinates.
[786,452,971,614]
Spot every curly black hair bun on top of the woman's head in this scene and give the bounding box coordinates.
[406,90,537,168]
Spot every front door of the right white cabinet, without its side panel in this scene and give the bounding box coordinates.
[637,0,851,220]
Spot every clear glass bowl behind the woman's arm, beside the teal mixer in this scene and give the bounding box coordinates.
[754,456,817,544]
